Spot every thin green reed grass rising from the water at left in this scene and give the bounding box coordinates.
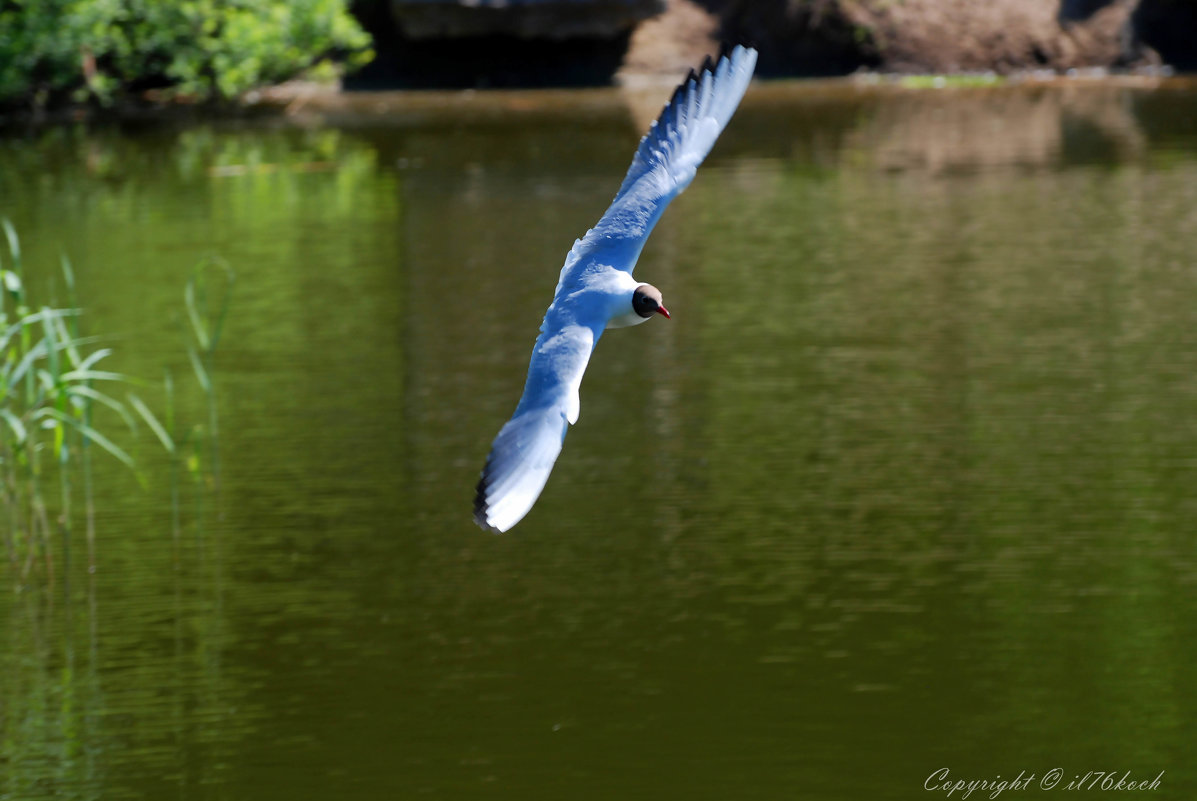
[0,219,233,581]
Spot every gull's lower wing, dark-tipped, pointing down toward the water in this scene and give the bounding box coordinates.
[474,320,601,532]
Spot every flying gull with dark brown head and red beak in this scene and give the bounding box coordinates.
[474,47,757,533]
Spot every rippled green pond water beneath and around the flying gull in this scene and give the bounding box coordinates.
[0,84,1197,801]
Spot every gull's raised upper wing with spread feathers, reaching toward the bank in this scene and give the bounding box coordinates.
[558,47,757,287]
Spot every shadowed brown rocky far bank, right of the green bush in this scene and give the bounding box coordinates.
[358,0,1197,85]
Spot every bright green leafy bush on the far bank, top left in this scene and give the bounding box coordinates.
[0,0,372,104]
